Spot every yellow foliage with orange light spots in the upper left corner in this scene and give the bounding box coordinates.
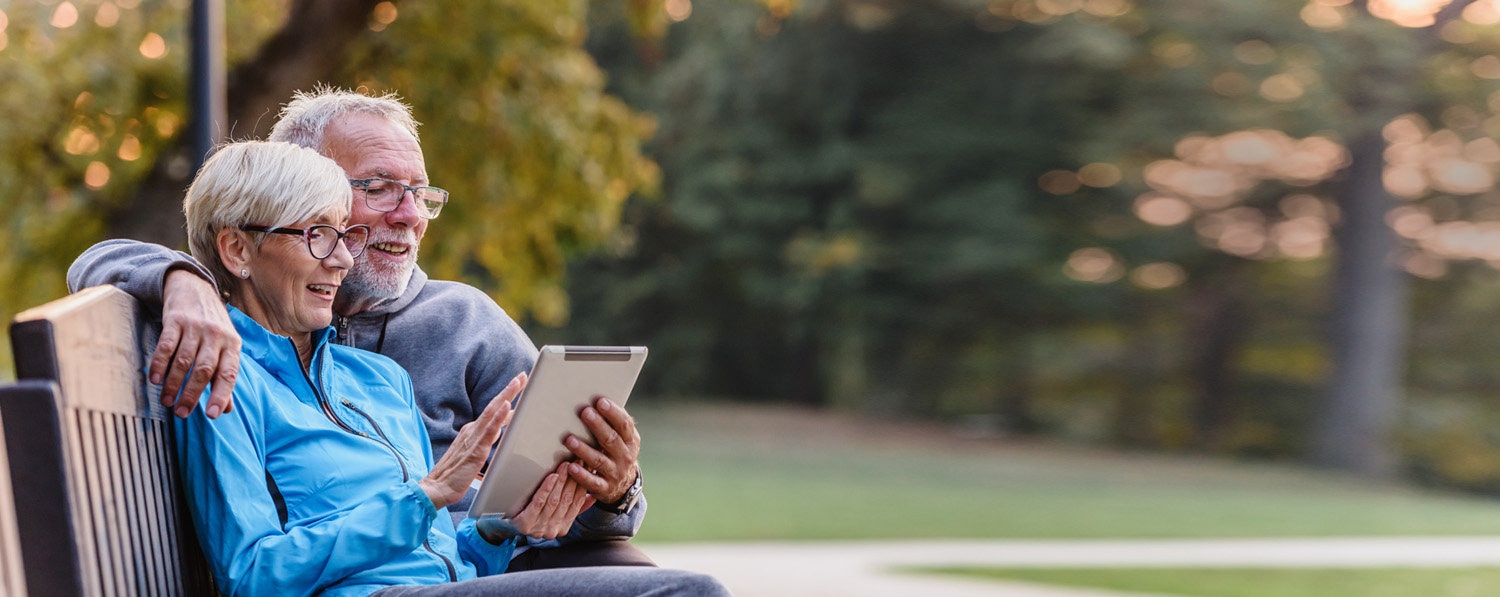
[0,3,183,320]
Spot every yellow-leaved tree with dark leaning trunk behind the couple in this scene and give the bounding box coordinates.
[0,0,656,331]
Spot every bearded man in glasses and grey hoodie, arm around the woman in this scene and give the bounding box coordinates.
[68,89,653,570]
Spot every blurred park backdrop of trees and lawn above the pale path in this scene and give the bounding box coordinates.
[11,0,1500,594]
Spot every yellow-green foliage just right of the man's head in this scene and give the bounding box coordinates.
[347,0,659,324]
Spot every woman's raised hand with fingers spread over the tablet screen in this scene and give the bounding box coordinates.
[417,374,527,509]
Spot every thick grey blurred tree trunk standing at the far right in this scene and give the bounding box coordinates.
[1311,0,1476,476]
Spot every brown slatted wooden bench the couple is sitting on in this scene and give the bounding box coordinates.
[0,287,216,596]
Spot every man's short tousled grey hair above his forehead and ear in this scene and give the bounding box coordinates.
[267,84,419,155]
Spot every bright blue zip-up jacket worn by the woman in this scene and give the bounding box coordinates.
[174,308,513,596]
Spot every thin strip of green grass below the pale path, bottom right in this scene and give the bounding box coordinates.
[933,569,1500,597]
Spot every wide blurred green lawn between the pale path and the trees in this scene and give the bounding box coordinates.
[630,396,1500,542]
